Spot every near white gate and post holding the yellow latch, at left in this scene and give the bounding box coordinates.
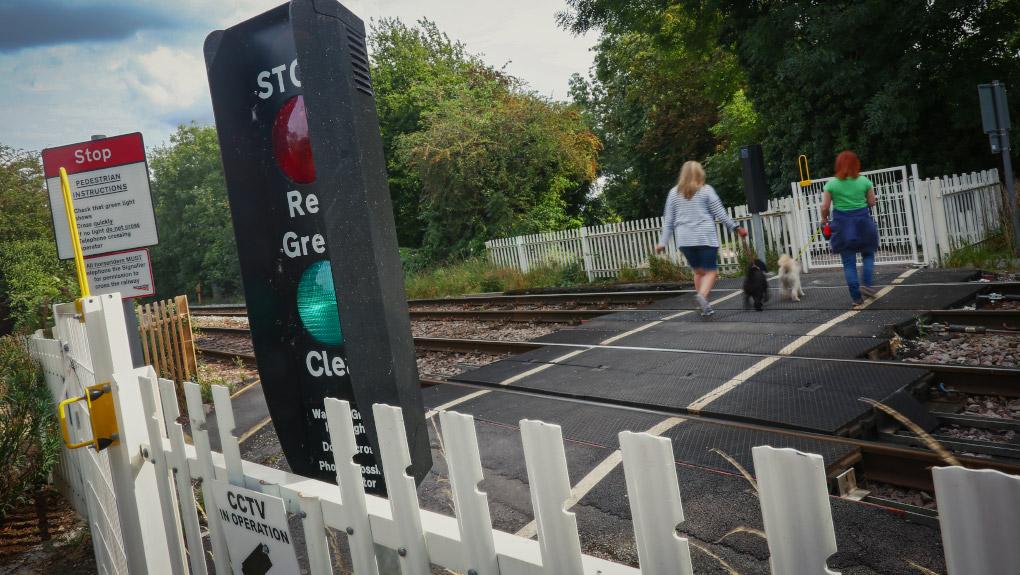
[28,294,170,575]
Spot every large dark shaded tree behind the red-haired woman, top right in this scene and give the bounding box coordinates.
[560,0,1020,194]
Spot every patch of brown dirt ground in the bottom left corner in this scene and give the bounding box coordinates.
[0,487,97,575]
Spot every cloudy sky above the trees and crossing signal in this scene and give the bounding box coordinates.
[0,0,595,150]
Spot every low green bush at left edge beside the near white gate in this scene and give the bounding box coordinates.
[0,335,60,522]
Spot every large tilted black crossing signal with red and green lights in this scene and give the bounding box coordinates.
[205,0,431,493]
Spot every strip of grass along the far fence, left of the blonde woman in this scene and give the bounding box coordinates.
[404,256,691,300]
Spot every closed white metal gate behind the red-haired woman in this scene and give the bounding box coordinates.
[791,166,923,269]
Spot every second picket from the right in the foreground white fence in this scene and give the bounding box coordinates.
[751,446,839,575]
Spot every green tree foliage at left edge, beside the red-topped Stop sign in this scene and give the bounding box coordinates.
[0,145,78,333]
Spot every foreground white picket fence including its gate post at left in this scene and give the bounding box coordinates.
[30,295,1020,575]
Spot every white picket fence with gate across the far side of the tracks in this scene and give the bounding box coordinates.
[486,165,1004,279]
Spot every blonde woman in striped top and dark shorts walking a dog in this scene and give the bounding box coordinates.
[655,161,748,317]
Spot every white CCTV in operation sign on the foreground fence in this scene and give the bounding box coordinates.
[212,479,301,575]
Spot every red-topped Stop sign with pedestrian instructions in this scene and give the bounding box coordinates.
[43,133,159,260]
